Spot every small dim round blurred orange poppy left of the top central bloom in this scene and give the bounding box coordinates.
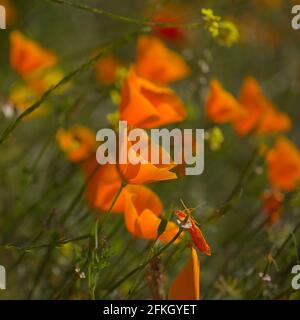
[95,55,122,86]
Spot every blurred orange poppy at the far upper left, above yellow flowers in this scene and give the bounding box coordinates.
[10,31,57,76]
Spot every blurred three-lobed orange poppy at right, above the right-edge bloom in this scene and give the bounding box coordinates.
[233,77,291,135]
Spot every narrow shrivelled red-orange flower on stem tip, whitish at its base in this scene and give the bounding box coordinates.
[176,211,211,256]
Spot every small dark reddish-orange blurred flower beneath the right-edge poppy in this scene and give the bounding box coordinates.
[262,189,284,226]
